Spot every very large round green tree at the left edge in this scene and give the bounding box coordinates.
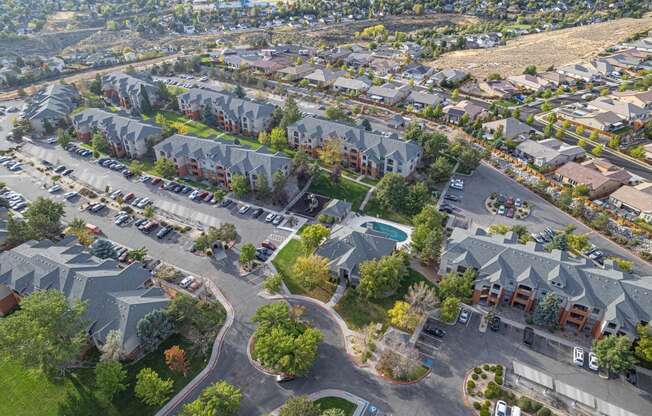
[0,290,87,376]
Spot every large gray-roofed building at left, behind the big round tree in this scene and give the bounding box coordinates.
[0,237,170,356]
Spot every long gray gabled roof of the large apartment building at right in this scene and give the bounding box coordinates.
[441,228,652,334]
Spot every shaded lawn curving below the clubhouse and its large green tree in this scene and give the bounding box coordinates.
[335,269,428,330]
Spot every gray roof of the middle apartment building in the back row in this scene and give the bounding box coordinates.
[178,88,276,120]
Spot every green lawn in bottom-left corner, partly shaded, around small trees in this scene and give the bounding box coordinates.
[0,335,206,416]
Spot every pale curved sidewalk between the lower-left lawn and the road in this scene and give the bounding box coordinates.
[156,280,235,416]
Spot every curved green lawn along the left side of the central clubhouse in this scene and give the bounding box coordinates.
[272,240,335,302]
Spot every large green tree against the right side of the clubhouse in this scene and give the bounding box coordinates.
[357,251,407,299]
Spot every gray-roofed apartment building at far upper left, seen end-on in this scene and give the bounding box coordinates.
[21,84,81,135]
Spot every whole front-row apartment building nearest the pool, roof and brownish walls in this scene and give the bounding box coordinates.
[154,134,291,190]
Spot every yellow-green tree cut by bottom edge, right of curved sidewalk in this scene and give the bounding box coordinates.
[180,381,242,416]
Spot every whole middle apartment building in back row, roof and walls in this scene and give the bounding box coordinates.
[177,88,275,136]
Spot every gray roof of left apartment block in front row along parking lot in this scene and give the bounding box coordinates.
[73,108,161,148]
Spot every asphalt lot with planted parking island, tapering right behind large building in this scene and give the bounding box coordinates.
[447,164,652,276]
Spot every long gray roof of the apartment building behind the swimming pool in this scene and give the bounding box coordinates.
[290,117,421,163]
